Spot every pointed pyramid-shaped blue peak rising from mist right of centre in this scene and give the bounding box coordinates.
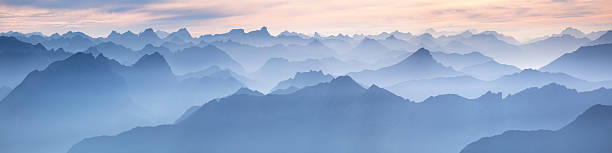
[349,48,461,86]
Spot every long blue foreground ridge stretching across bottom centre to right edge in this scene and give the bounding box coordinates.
[64,76,612,153]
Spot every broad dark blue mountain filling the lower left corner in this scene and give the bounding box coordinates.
[0,53,147,153]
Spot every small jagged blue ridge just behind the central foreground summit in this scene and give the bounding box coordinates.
[271,71,334,91]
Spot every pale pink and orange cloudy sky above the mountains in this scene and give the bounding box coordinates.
[0,0,612,41]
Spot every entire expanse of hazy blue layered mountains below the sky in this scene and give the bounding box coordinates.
[0,27,612,153]
